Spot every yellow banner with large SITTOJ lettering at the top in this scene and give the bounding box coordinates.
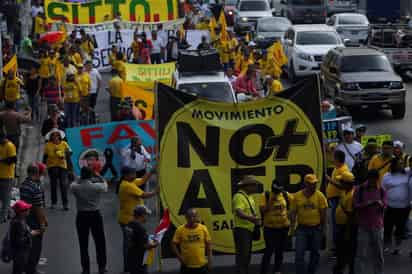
[44,0,178,24]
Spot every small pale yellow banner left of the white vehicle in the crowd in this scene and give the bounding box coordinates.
[126,63,175,90]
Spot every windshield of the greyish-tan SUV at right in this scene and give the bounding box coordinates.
[341,55,392,73]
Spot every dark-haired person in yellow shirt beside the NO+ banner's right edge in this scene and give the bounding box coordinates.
[326,150,350,253]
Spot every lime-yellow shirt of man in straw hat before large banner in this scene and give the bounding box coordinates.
[232,191,258,231]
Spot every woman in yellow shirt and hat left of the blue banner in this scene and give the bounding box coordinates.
[43,128,73,210]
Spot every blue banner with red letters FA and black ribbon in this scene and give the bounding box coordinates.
[66,121,156,178]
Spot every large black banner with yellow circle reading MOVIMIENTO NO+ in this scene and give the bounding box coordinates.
[156,77,324,253]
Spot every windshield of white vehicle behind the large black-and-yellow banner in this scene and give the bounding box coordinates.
[179,82,234,103]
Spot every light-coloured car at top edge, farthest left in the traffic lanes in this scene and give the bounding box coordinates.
[234,0,275,34]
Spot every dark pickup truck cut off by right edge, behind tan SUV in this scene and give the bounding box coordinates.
[367,24,412,75]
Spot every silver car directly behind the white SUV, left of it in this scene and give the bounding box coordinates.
[255,17,292,48]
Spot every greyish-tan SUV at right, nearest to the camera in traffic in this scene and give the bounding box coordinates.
[321,48,406,119]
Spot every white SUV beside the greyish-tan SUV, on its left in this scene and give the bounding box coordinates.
[283,25,344,80]
